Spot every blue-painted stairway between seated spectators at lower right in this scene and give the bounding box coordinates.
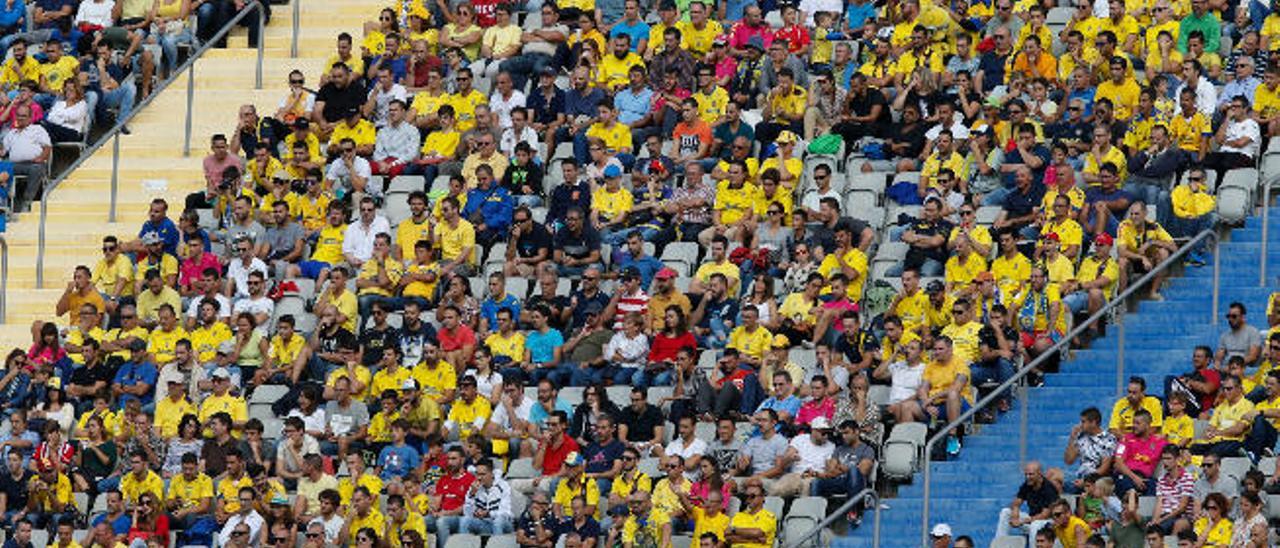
[832,207,1280,548]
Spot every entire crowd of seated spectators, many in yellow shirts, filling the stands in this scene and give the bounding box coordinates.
[0,0,1280,548]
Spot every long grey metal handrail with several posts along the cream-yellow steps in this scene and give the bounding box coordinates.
[36,0,267,289]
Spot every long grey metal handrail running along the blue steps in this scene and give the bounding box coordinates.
[920,228,1219,545]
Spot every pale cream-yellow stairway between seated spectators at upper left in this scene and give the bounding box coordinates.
[0,0,383,348]
